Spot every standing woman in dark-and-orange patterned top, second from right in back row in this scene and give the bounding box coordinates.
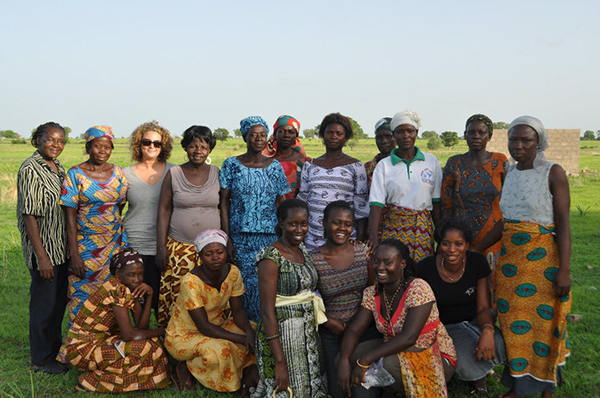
[442,114,508,257]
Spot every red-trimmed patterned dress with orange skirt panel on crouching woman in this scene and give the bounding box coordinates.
[362,279,456,398]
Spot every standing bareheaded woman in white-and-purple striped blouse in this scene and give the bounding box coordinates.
[298,113,369,250]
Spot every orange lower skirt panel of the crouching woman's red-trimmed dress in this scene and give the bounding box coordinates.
[398,344,448,398]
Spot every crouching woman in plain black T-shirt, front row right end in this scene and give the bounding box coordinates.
[417,218,506,397]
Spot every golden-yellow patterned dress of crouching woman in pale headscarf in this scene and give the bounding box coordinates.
[165,265,256,392]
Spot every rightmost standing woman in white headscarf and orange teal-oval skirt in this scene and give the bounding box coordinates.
[497,116,571,398]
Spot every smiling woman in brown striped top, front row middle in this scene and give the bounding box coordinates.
[310,200,381,398]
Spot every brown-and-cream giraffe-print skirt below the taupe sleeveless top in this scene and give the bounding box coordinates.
[156,236,200,327]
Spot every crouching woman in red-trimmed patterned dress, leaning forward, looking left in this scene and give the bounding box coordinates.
[338,239,456,397]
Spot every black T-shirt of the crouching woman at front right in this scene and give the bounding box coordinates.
[417,251,492,324]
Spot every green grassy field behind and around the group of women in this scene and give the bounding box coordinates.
[0,139,600,398]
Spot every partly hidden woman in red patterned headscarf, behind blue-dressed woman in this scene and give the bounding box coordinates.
[262,115,307,199]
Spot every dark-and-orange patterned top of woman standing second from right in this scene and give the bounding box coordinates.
[442,152,508,255]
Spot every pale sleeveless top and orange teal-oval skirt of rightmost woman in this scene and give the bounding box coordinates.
[496,162,571,395]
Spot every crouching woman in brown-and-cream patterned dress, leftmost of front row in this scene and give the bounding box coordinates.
[57,249,170,393]
